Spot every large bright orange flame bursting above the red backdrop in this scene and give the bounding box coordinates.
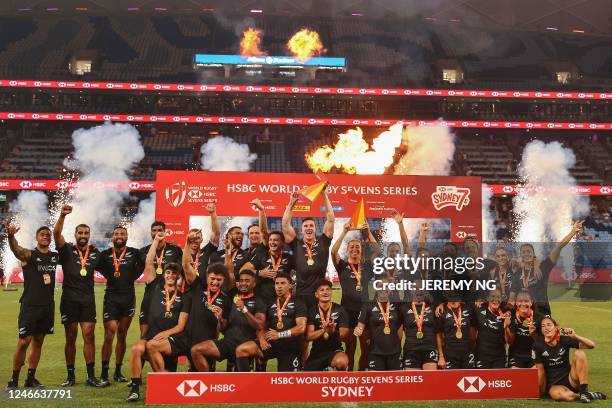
[306,122,403,174]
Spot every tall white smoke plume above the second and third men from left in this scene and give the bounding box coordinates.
[64,122,145,245]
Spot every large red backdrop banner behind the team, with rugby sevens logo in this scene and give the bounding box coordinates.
[155,170,482,241]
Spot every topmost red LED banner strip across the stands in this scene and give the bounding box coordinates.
[0,79,612,100]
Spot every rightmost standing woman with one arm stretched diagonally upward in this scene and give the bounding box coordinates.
[510,221,583,315]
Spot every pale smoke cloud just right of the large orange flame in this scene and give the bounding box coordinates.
[394,125,455,176]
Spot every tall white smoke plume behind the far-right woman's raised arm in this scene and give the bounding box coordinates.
[514,140,589,242]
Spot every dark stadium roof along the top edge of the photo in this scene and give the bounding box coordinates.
[0,0,612,35]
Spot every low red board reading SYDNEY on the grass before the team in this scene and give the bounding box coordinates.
[146,369,539,405]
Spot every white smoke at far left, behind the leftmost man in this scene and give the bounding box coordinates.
[2,191,49,284]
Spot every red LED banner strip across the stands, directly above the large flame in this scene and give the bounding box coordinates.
[0,112,612,130]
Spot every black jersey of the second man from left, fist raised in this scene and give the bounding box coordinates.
[58,242,100,301]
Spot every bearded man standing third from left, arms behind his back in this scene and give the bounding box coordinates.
[98,226,144,387]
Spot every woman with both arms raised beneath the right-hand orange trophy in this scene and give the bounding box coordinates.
[331,223,380,371]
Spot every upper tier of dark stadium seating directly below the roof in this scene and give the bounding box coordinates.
[0,15,612,87]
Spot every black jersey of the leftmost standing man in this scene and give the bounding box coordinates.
[19,248,59,306]
